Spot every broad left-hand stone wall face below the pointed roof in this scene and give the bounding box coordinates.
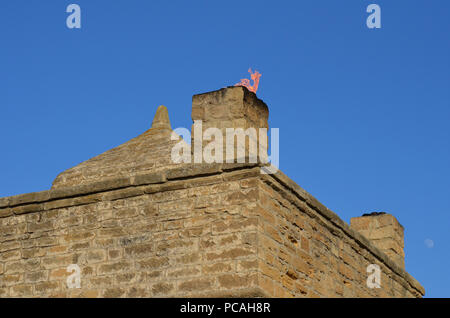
[0,167,262,297]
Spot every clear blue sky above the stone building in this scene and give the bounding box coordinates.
[0,0,450,297]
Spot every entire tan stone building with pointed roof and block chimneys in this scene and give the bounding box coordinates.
[0,87,424,297]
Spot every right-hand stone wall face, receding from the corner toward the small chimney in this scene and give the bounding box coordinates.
[258,172,425,297]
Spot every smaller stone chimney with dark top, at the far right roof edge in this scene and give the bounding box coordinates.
[350,212,405,269]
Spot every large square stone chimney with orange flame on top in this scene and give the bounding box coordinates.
[191,86,269,162]
